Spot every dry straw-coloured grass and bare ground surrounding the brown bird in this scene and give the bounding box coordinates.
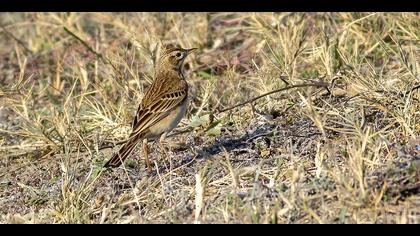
[0,13,420,223]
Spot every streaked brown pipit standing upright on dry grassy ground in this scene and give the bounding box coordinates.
[104,48,196,171]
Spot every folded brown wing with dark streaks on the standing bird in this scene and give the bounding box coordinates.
[130,81,188,137]
